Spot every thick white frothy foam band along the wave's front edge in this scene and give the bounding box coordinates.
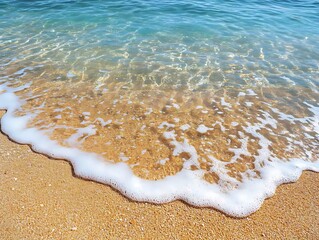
[0,84,319,217]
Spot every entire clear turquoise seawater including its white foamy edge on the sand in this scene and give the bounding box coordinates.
[0,0,319,217]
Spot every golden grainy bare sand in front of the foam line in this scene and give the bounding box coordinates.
[0,109,319,239]
